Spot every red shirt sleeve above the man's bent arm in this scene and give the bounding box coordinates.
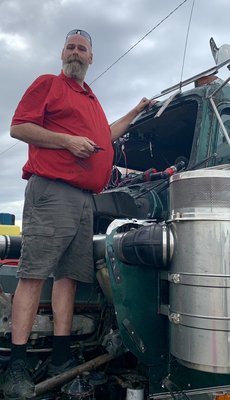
[11,75,55,126]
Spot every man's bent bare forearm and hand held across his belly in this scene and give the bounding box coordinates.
[10,122,96,158]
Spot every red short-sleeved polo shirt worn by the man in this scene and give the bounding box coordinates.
[12,73,113,193]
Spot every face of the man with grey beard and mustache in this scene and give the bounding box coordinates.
[61,34,93,81]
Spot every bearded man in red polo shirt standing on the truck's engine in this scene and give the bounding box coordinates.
[4,29,152,400]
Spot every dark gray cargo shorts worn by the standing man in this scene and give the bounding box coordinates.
[17,175,94,283]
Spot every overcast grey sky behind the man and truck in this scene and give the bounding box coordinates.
[0,0,230,227]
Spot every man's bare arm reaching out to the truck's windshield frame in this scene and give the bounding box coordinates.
[110,97,151,142]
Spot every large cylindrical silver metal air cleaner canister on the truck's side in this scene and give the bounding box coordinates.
[168,168,230,374]
